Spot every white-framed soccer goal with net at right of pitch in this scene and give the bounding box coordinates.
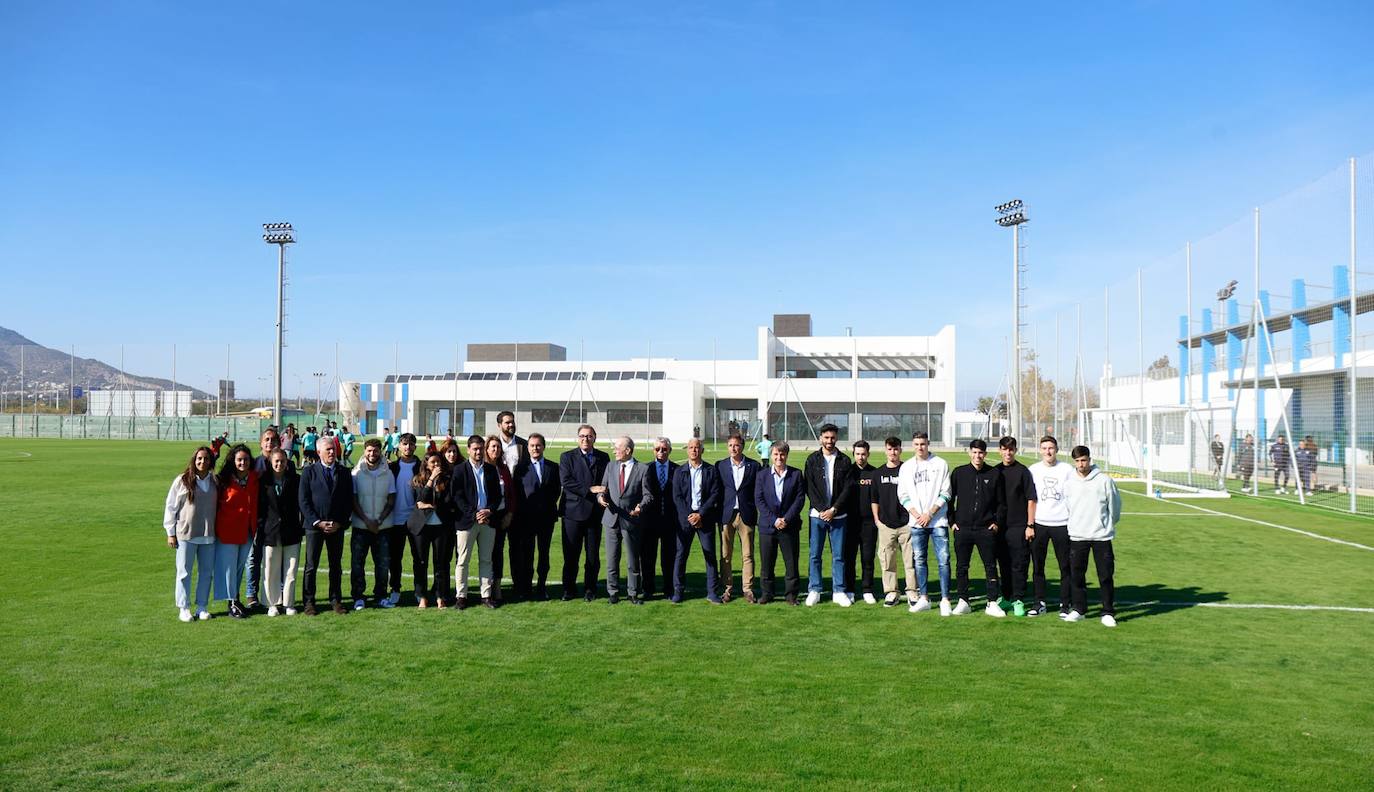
[1080,406,1237,498]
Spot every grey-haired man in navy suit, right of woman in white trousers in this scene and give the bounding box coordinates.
[300,443,353,616]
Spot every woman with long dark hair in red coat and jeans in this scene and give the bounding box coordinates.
[214,443,258,619]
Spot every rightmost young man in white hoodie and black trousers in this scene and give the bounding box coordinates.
[1061,446,1121,627]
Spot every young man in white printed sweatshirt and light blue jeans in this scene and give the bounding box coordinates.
[897,432,954,616]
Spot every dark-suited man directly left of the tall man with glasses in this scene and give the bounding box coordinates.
[511,433,563,600]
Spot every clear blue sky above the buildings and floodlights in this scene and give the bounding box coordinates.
[0,1,1374,396]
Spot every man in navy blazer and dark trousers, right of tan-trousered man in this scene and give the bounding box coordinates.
[754,443,807,605]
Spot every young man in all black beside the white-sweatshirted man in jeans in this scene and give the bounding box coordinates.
[949,440,1007,619]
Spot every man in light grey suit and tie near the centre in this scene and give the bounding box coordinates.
[594,437,654,605]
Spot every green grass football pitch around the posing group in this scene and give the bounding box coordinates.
[0,439,1374,791]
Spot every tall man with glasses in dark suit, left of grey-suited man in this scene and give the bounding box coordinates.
[558,424,610,602]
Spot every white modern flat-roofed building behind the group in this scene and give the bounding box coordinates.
[339,314,955,446]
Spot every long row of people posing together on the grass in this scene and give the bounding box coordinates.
[164,411,1121,626]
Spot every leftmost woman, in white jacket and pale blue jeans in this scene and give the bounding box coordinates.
[162,446,218,622]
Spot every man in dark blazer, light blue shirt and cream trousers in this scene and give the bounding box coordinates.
[450,435,503,611]
